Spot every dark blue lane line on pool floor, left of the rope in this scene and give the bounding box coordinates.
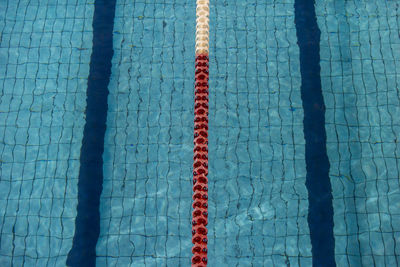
[67,0,116,267]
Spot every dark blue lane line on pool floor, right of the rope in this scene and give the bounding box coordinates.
[294,0,336,267]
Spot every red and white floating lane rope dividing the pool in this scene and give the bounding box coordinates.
[192,0,209,267]
